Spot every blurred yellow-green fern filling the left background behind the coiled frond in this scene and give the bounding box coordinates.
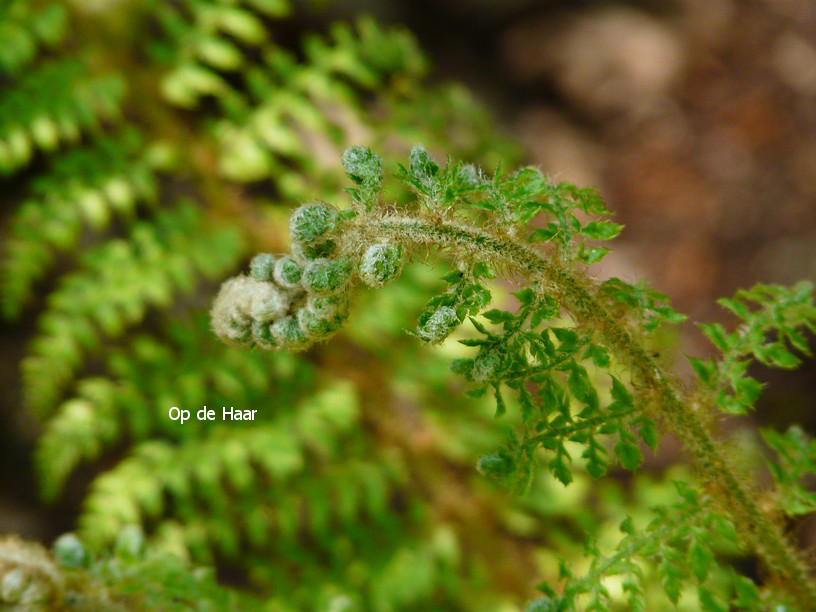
[0,1,548,609]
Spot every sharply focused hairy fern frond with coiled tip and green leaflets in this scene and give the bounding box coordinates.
[211,146,816,610]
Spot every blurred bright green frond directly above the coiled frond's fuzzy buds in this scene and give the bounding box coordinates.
[210,19,425,188]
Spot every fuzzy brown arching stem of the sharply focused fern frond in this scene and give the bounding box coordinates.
[360,217,816,610]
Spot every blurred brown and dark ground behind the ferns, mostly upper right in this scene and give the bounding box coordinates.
[0,0,816,604]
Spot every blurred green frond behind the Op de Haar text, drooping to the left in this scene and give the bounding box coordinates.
[36,318,294,500]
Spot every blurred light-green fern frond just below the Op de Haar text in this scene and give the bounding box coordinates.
[80,387,356,554]
